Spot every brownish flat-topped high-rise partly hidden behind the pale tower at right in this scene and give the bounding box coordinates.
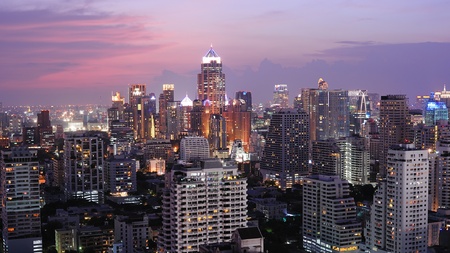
[377,95,413,177]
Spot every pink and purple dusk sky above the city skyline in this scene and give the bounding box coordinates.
[0,0,450,106]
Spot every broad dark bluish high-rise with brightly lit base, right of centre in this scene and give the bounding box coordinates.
[261,108,309,189]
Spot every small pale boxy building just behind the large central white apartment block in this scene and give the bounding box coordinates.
[180,136,209,162]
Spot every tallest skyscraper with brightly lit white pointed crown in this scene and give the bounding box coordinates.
[197,47,226,114]
